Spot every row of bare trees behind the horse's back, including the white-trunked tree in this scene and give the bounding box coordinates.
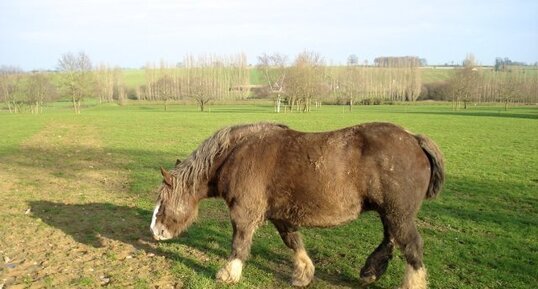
[257,51,422,112]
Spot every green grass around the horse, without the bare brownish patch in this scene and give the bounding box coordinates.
[0,104,538,289]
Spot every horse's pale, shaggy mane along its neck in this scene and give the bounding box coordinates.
[165,122,288,198]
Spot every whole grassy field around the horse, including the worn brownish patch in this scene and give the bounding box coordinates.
[0,103,538,289]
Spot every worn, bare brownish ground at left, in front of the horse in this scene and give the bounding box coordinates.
[0,125,181,288]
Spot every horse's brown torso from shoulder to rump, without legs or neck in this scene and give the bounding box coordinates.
[216,123,427,227]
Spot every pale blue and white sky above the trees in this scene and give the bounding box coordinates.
[0,0,538,70]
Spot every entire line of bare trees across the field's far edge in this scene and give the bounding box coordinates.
[0,51,538,113]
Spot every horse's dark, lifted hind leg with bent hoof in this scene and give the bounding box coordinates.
[360,215,394,285]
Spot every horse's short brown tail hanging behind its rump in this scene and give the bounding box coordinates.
[415,135,445,199]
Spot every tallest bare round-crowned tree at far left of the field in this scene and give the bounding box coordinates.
[58,52,93,114]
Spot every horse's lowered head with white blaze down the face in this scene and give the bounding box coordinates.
[150,168,198,240]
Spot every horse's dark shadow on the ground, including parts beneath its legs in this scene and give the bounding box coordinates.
[29,201,372,288]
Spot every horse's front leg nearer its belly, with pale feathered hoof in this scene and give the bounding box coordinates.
[272,221,315,286]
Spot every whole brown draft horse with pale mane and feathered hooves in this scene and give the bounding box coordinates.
[151,123,444,288]
